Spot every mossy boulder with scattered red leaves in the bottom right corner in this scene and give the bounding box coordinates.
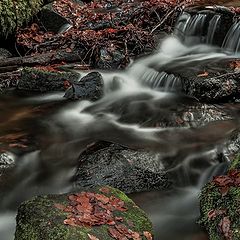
[199,155,240,240]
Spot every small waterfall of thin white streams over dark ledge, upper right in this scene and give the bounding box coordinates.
[174,6,236,49]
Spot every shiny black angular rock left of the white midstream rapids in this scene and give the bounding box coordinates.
[64,72,103,101]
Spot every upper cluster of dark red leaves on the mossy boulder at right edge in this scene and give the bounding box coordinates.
[213,170,240,196]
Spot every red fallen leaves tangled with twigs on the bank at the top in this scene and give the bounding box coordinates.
[17,0,182,67]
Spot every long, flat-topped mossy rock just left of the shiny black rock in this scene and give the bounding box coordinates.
[17,68,79,92]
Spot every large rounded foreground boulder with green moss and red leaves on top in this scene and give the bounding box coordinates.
[15,187,152,240]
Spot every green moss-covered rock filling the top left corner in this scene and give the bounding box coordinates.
[0,0,43,37]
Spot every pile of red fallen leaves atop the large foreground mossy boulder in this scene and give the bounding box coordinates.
[55,188,152,240]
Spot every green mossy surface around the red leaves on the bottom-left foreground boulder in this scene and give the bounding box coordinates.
[15,187,152,240]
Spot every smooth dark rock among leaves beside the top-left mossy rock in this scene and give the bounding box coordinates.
[39,3,70,33]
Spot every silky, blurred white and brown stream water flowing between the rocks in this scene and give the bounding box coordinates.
[0,36,239,240]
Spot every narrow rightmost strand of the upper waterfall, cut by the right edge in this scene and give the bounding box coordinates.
[222,21,240,53]
